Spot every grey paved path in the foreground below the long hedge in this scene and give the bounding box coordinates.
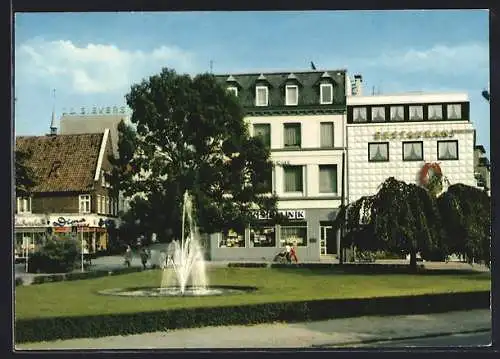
[16,310,491,350]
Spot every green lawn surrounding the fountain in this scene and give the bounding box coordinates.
[15,268,490,319]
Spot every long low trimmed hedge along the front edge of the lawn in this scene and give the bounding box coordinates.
[15,291,490,343]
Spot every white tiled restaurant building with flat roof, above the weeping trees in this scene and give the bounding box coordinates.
[346,93,476,202]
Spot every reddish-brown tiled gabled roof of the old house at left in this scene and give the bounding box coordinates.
[16,133,104,193]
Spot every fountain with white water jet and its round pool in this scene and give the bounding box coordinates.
[99,191,256,297]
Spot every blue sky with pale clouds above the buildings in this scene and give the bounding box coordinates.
[14,10,490,153]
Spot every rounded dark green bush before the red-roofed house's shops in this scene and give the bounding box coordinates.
[28,239,80,273]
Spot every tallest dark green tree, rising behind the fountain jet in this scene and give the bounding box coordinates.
[116,68,276,242]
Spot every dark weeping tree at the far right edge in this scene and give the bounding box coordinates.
[438,183,491,266]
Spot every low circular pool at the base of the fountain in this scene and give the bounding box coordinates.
[98,286,257,297]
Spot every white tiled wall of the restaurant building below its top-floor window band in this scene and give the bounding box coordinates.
[347,122,475,202]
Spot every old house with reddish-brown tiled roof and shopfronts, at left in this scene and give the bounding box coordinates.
[15,130,118,255]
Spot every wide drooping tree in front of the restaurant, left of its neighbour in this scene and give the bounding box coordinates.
[338,177,442,268]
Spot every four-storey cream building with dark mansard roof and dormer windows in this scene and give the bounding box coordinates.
[211,70,351,261]
